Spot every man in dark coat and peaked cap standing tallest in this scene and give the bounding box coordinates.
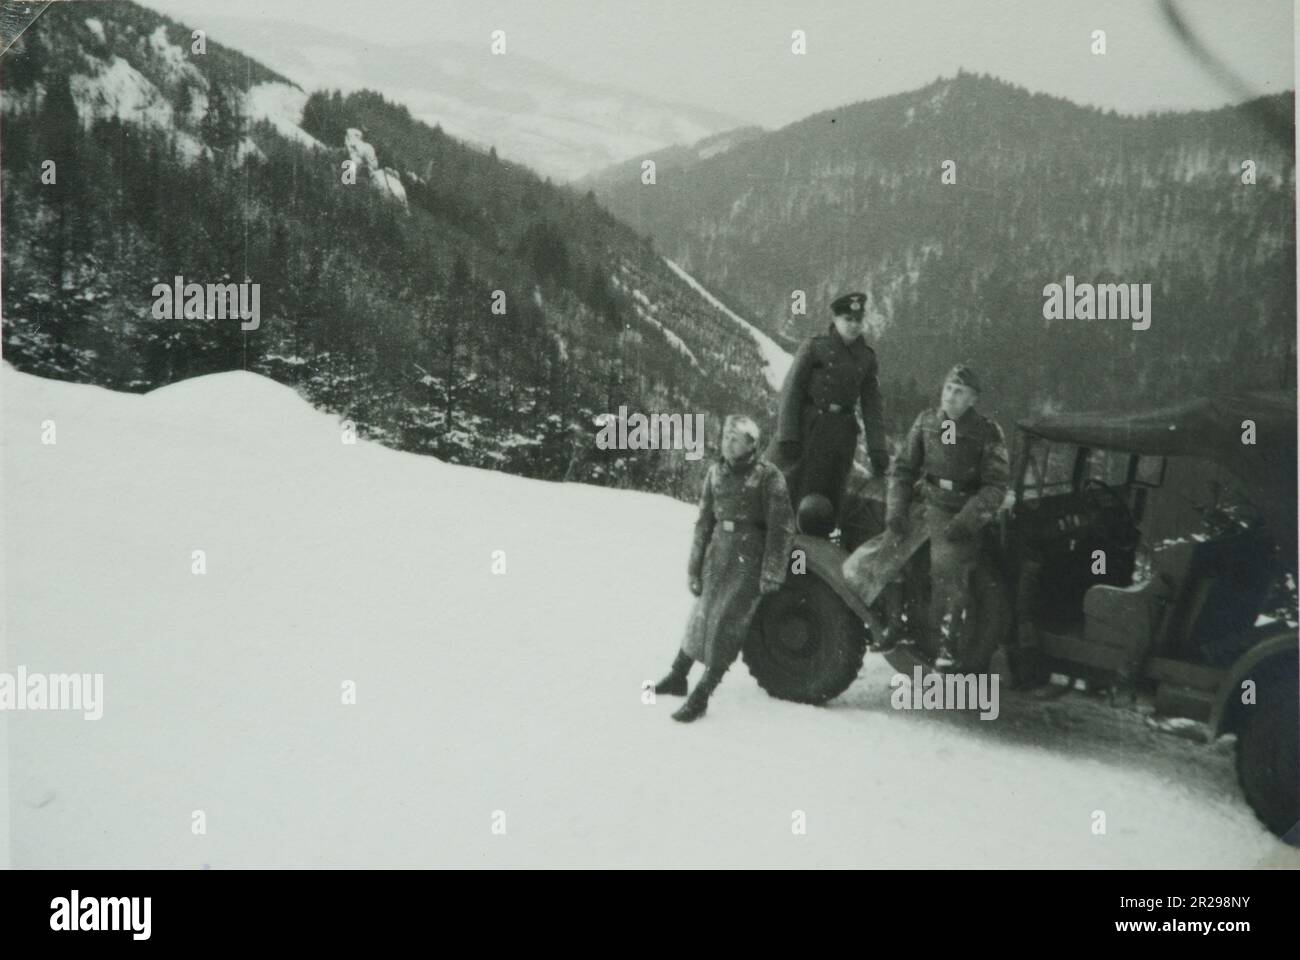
[767,293,889,518]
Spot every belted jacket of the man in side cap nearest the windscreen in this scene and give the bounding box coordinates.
[889,407,1010,533]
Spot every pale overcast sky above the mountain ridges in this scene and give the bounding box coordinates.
[146,0,1295,127]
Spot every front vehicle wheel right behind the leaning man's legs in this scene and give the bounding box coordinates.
[742,574,867,704]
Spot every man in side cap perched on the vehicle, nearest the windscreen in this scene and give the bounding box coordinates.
[885,363,1010,669]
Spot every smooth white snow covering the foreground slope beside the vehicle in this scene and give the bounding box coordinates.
[0,366,1296,868]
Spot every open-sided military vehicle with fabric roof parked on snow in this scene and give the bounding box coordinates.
[744,394,1300,843]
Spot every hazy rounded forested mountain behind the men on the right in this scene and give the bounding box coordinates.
[590,73,1296,431]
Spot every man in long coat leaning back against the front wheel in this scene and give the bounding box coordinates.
[654,415,794,723]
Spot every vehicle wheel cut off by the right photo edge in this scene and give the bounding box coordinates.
[1236,683,1300,846]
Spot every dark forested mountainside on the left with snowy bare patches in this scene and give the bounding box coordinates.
[0,3,771,497]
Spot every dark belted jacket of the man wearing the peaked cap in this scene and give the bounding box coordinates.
[776,324,889,458]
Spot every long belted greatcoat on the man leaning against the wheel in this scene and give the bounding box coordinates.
[681,451,794,665]
